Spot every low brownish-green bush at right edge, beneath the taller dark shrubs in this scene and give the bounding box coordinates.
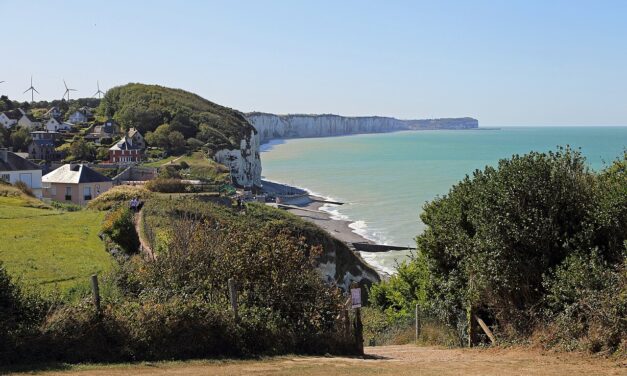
[539,252,627,352]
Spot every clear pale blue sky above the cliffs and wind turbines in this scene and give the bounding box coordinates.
[0,0,627,126]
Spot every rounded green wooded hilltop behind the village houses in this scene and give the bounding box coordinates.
[99,83,254,151]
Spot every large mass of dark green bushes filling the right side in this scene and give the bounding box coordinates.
[371,149,627,351]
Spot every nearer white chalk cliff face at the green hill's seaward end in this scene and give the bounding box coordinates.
[213,130,261,187]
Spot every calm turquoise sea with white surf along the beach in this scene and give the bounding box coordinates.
[261,126,627,274]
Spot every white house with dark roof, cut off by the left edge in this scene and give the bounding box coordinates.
[0,149,42,198]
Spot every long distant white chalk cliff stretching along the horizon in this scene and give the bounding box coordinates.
[245,112,479,143]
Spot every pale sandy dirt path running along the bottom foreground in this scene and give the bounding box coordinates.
[18,345,627,376]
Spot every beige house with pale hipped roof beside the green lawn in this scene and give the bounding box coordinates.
[42,164,113,205]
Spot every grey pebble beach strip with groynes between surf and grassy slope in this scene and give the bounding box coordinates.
[263,180,391,278]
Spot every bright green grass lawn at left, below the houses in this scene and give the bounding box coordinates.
[0,197,113,295]
